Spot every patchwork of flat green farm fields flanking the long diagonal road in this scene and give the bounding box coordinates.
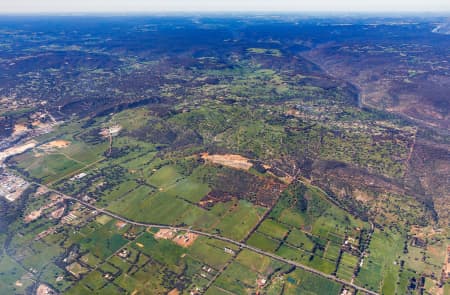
[1,103,448,294]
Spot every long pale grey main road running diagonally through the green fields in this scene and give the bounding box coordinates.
[38,183,378,295]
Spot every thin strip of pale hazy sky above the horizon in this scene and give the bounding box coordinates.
[0,0,450,14]
